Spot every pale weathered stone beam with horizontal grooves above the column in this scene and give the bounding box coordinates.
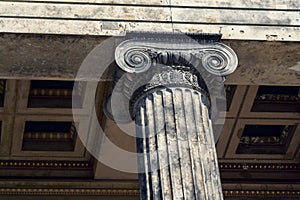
[0,0,300,41]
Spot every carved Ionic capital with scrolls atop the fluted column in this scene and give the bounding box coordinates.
[105,33,238,122]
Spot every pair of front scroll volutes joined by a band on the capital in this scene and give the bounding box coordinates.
[115,39,237,76]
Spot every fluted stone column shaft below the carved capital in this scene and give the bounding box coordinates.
[135,87,223,200]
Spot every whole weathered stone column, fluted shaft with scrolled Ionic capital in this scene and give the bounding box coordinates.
[109,35,237,200]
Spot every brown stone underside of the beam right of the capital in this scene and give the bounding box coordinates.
[224,41,300,85]
